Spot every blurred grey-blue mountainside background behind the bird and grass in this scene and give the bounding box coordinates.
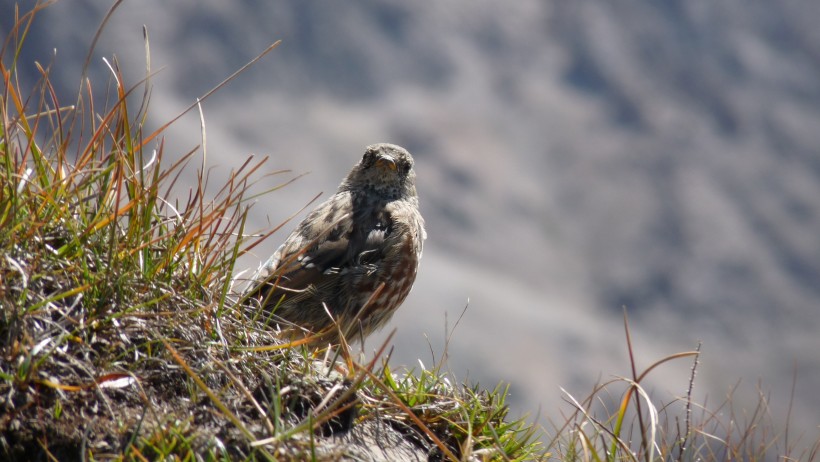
[0,0,820,435]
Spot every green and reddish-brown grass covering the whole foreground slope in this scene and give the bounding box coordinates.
[0,4,820,461]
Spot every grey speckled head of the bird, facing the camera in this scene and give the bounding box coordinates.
[339,143,416,199]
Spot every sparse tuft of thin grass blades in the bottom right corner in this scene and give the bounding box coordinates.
[547,313,820,462]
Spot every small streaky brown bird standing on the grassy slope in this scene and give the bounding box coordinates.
[247,143,427,344]
